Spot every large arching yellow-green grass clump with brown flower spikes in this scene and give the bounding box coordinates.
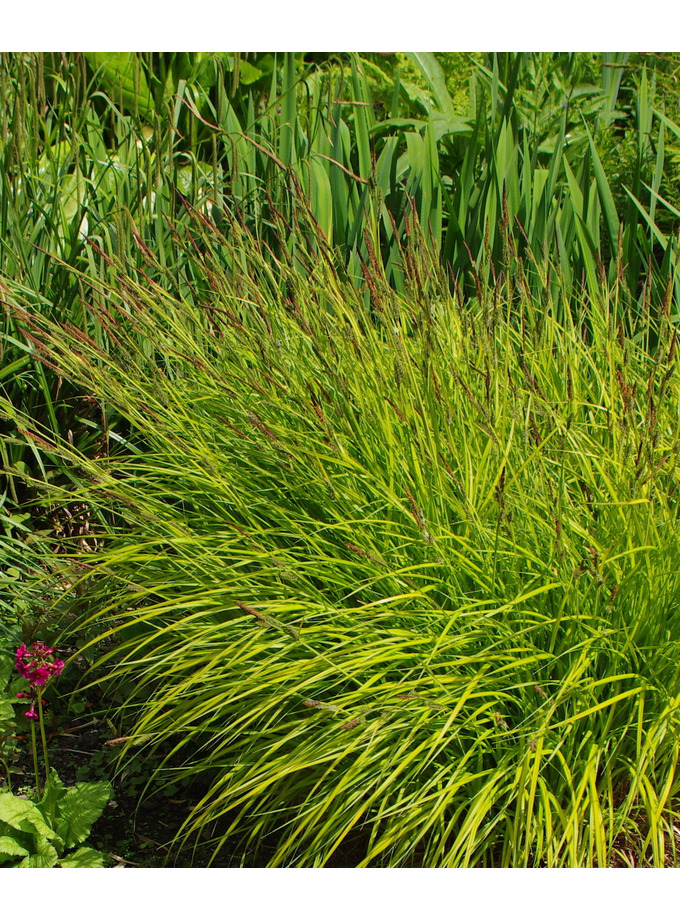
[3,207,680,867]
